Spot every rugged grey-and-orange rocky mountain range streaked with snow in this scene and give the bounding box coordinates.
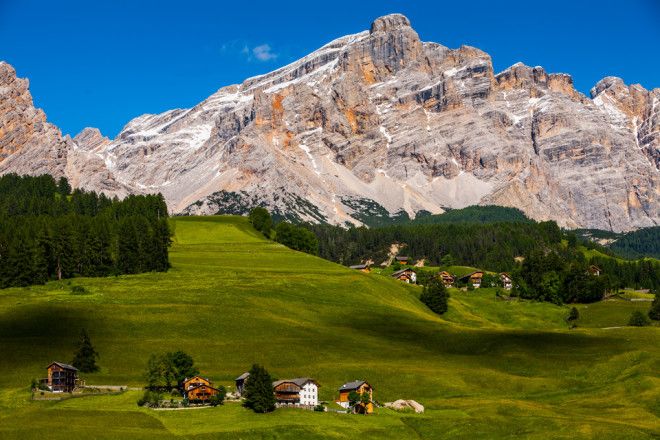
[0,14,660,231]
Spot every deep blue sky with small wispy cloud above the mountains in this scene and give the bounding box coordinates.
[0,0,660,137]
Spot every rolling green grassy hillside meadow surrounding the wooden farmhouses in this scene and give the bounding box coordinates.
[0,217,660,439]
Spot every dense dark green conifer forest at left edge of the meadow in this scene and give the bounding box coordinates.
[0,174,170,288]
